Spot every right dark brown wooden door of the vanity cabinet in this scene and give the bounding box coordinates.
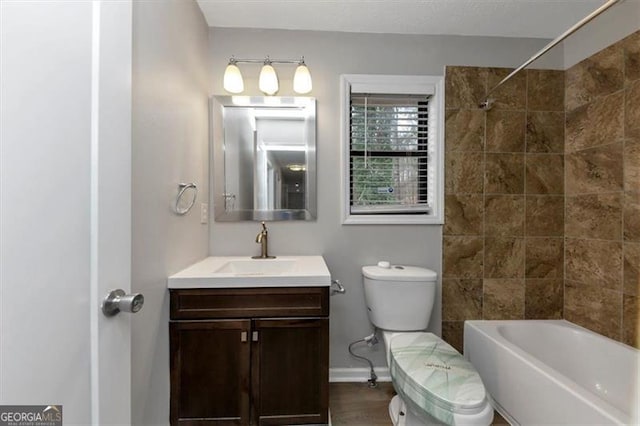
[251,318,329,425]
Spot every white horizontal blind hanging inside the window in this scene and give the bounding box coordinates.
[349,92,430,215]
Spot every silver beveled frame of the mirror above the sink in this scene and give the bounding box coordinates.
[209,95,317,222]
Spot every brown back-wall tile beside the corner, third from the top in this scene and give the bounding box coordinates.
[525,154,564,194]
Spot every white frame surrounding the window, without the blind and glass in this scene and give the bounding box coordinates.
[340,74,444,225]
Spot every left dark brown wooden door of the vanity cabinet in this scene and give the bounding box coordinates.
[169,320,251,425]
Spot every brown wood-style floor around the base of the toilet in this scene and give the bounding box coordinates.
[329,382,509,426]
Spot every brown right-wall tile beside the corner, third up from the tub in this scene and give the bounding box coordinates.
[564,194,622,240]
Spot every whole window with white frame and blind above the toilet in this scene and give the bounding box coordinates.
[342,75,443,224]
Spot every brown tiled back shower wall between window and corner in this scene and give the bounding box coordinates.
[442,67,565,349]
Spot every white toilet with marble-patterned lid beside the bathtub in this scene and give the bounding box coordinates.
[362,262,493,426]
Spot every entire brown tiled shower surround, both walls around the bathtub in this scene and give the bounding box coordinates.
[442,32,640,350]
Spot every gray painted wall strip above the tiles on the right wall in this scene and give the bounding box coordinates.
[563,0,640,69]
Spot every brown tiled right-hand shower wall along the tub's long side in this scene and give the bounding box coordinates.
[564,32,640,346]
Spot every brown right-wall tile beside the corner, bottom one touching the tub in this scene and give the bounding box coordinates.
[564,280,622,340]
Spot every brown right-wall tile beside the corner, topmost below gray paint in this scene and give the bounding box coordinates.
[565,41,624,111]
